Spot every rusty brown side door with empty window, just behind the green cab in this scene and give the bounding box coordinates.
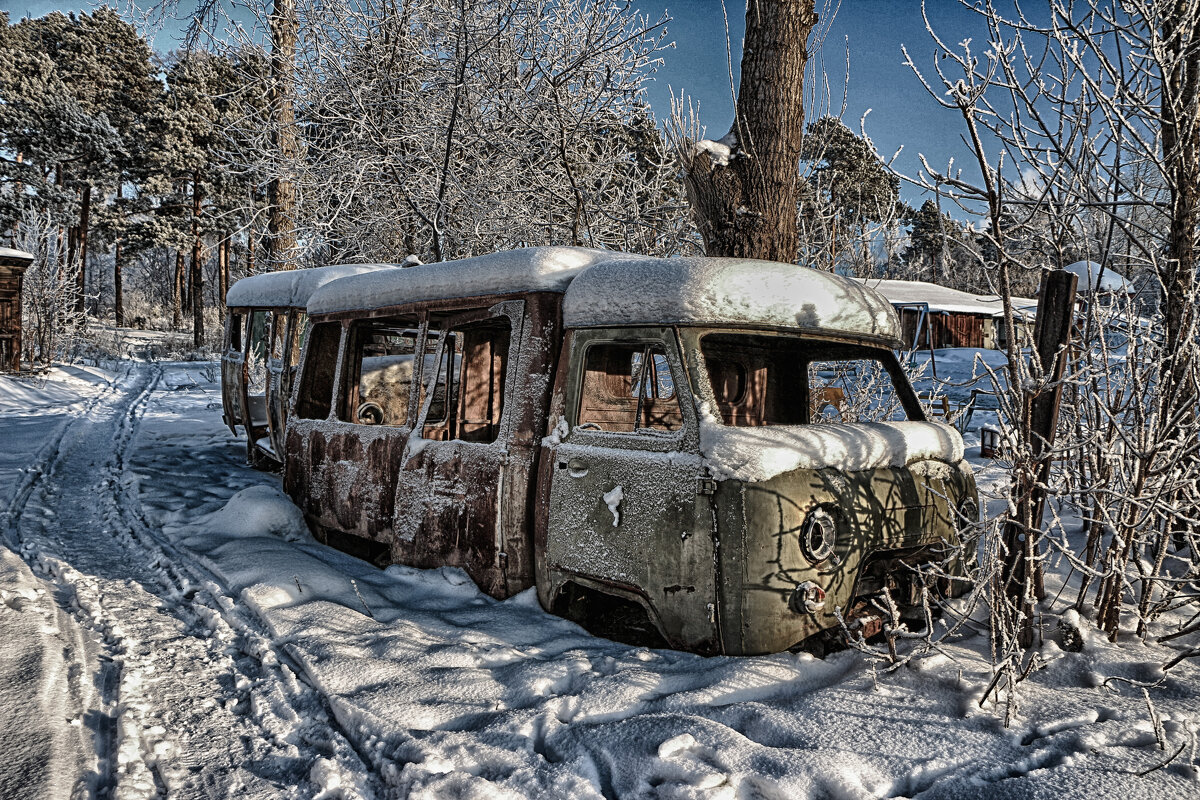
[392,300,525,597]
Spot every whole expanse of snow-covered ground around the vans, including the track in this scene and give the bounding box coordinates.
[0,359,1200,799]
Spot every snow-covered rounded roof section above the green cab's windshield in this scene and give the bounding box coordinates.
[563,255,900,339]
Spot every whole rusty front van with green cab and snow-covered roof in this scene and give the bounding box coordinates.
[284,247,978,655]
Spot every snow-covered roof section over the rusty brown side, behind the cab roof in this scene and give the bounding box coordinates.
[308,247,612,314]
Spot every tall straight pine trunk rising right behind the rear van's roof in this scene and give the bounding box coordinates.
[266,0,300,270]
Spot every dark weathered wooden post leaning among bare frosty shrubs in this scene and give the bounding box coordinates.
[1001,270,1079,648]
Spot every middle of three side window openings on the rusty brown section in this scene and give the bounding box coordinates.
[340,320,418,427]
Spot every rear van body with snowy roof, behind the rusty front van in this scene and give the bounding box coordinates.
[221,264,395,467]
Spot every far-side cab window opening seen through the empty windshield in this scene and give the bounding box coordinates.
[809,359,908,423]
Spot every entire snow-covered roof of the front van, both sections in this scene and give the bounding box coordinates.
[308,247,900,339]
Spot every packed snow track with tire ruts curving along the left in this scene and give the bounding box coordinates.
[7,367,374,798]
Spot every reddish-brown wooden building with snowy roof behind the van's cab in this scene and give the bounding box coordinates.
[863,281,1037,350]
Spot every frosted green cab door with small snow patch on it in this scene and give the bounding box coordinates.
[539,329,720,652]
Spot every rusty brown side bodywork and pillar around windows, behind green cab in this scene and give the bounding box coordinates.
[294,293,562,597]
